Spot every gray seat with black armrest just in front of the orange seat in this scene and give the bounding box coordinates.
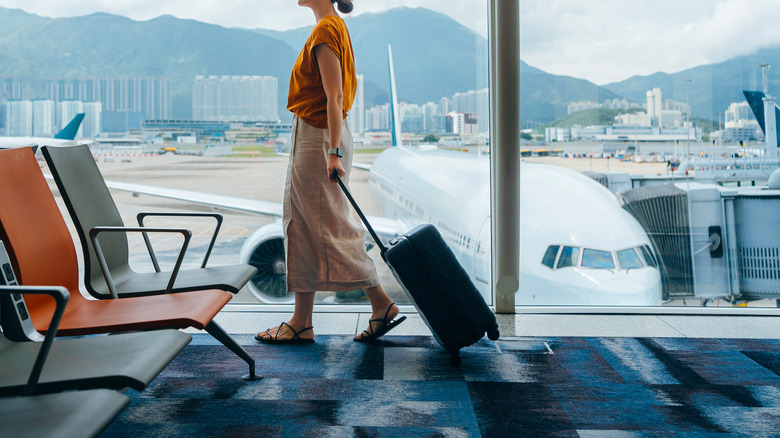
[0,286,192,396]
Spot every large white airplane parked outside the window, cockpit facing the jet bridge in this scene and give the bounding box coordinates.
[94,44,661,306]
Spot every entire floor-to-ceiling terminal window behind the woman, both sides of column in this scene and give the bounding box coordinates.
[27,0,780,314]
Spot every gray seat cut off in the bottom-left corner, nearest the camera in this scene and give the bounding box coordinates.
[0,390,130,438]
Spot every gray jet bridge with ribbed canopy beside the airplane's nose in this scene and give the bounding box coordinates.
[621,174,780,301]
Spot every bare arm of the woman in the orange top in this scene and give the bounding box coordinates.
[314,44,346,183]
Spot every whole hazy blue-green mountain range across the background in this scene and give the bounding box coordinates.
[0,7,780,123]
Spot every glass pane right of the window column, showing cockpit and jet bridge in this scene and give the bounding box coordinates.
[520,0,780,308]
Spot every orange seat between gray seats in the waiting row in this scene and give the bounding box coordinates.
[0,148,256,379]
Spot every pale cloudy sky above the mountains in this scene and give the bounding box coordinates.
[0,0,780,85]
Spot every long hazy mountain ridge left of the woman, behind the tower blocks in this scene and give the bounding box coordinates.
[0,9,297,118]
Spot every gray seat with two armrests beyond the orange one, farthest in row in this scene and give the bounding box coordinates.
[41,145,257,298]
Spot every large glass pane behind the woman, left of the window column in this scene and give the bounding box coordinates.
[0,0,488,304]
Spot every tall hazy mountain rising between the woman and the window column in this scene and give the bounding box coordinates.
[254,7,488,107]
